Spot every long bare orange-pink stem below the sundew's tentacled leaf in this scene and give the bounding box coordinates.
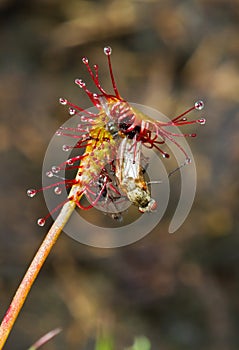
[0,200,76,350]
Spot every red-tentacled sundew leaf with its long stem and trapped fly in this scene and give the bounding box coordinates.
[0,47,205,349]
